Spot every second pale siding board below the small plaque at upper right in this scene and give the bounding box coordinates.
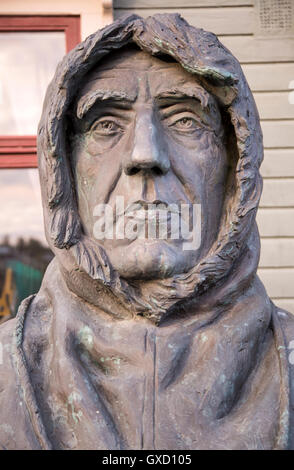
[242,62,294,91]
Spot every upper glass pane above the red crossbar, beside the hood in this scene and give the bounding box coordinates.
[0,31,65,135]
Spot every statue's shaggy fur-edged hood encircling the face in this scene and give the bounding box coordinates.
[38,14,263,322]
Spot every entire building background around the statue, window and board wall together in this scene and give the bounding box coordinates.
[0,0,294,322]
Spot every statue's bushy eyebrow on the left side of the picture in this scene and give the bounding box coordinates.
[77,89,136,119]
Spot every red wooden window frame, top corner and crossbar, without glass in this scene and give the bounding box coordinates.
[0,15,81,168]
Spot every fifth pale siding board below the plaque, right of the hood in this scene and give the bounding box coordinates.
[261,150,294,177]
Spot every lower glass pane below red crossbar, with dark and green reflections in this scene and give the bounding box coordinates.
[0,169,53,321]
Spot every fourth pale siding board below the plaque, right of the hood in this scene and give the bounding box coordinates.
[261,120,294,148]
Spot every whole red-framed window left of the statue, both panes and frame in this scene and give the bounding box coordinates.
[0,16,80,322]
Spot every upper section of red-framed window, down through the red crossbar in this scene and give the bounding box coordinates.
[0,16,80,168]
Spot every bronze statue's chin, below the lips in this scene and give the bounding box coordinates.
[107,240,199,280]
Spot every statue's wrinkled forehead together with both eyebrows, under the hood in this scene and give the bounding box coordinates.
[76,60,221,135]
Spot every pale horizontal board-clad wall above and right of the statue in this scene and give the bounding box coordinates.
[113,0,294,313]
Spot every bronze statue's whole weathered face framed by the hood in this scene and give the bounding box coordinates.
[72,49,227,279]
